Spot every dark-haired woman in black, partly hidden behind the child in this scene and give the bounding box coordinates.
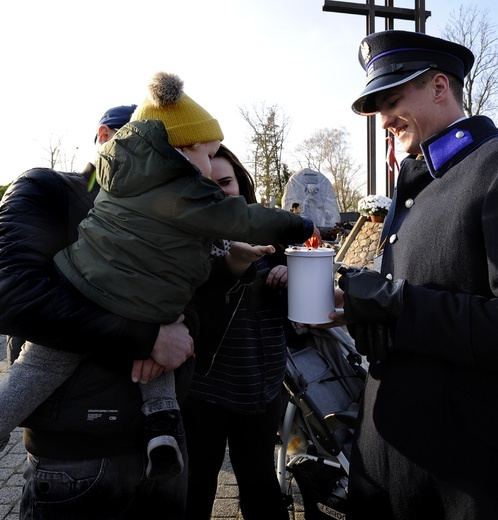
[182,145,289,520]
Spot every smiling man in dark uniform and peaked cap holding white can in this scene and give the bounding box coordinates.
[310,31,498,520]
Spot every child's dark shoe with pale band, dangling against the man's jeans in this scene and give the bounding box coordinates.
[145,410,183,480]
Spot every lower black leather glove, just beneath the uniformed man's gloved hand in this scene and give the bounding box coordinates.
[347,324,394,363]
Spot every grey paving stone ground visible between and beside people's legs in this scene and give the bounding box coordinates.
[0,335,304,520]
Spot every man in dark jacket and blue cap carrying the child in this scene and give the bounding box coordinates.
[0,105,198,520]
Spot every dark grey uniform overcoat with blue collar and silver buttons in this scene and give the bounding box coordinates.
[348,116,498,520]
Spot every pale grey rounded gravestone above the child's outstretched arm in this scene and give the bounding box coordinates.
[282,168,341,227]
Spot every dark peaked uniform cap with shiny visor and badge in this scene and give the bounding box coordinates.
[351,30,474,116]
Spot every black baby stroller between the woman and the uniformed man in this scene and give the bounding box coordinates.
[277,325,366,520]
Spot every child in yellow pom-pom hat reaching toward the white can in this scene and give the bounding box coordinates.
[0,72,317,479]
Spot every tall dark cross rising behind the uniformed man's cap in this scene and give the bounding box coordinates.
[323,0,431,198]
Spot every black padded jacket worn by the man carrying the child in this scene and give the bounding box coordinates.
[0,165,198,458]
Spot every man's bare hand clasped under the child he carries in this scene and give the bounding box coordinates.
[151,314,194,371]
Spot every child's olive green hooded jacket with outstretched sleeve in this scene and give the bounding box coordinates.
[55,120,313,323]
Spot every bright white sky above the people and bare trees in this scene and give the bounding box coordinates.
[0,0,498,192]
